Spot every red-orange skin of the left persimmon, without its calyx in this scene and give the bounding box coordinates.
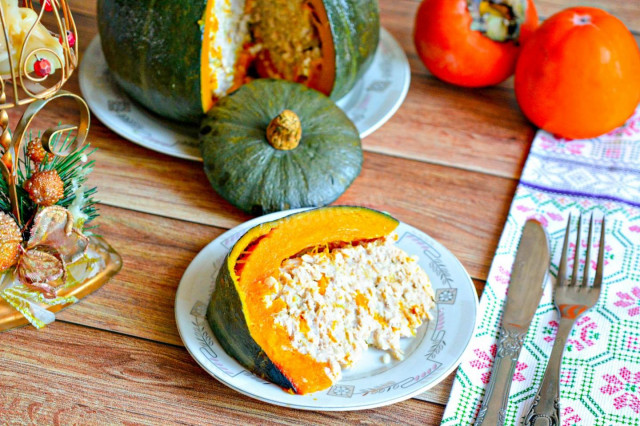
[414,0,538,87]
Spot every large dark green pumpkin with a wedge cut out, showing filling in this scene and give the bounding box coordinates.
[98,0,380,122]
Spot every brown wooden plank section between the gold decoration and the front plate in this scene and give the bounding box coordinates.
[58,206,224,346]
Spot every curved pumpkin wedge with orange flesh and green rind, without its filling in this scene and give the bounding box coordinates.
[207,206,398,394]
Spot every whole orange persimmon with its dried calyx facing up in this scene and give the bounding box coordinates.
[414,0,538,87]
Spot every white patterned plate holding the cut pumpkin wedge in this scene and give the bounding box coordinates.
[175,209,478,411]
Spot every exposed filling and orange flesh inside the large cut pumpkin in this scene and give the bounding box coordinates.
[201,0,323,104]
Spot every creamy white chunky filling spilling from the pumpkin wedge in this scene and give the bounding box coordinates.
[264,234,435,382]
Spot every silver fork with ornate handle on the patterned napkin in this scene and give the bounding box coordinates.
[523,214,605,426]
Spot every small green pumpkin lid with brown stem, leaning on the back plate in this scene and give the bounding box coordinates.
[200,79,362,215]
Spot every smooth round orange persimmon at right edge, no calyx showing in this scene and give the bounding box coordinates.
[515,7,640,139]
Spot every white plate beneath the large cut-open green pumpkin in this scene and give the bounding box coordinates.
[79,28,411,161]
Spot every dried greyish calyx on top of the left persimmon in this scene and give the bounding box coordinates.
[467,0,527,42]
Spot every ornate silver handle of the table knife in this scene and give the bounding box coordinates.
[474,327,527,426]
